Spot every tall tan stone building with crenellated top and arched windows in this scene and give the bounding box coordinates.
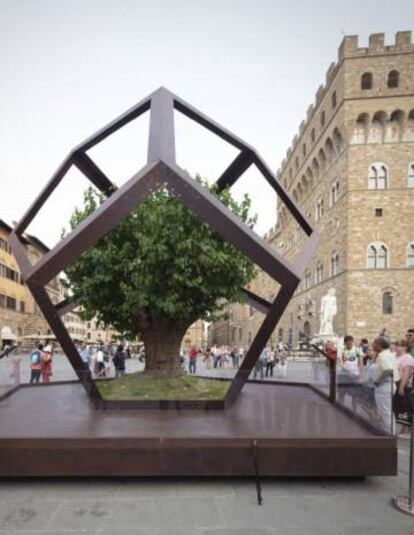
[213,32,414,344]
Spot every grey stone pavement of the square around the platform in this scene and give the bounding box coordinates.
[0,355,414,535]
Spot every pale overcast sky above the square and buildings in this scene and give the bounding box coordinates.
[0,0,414,246]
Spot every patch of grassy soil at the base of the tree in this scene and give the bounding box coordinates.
[95,372,230,400]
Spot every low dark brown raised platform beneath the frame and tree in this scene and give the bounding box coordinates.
[0,383,397,477]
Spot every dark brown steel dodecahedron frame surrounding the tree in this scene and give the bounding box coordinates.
[10,87,318,408]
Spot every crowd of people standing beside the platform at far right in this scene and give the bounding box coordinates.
[324,329,414,436]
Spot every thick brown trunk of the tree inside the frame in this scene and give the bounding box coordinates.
[141,318,187,377]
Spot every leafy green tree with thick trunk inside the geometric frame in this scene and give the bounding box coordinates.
[65,177,256,375]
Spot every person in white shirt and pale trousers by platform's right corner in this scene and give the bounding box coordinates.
[372,336,400,433]
